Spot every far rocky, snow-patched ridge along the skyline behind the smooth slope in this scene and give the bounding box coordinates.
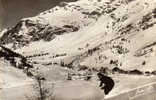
[0,0,138,49]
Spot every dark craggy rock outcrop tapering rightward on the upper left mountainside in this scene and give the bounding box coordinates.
[0,19,79,49]
